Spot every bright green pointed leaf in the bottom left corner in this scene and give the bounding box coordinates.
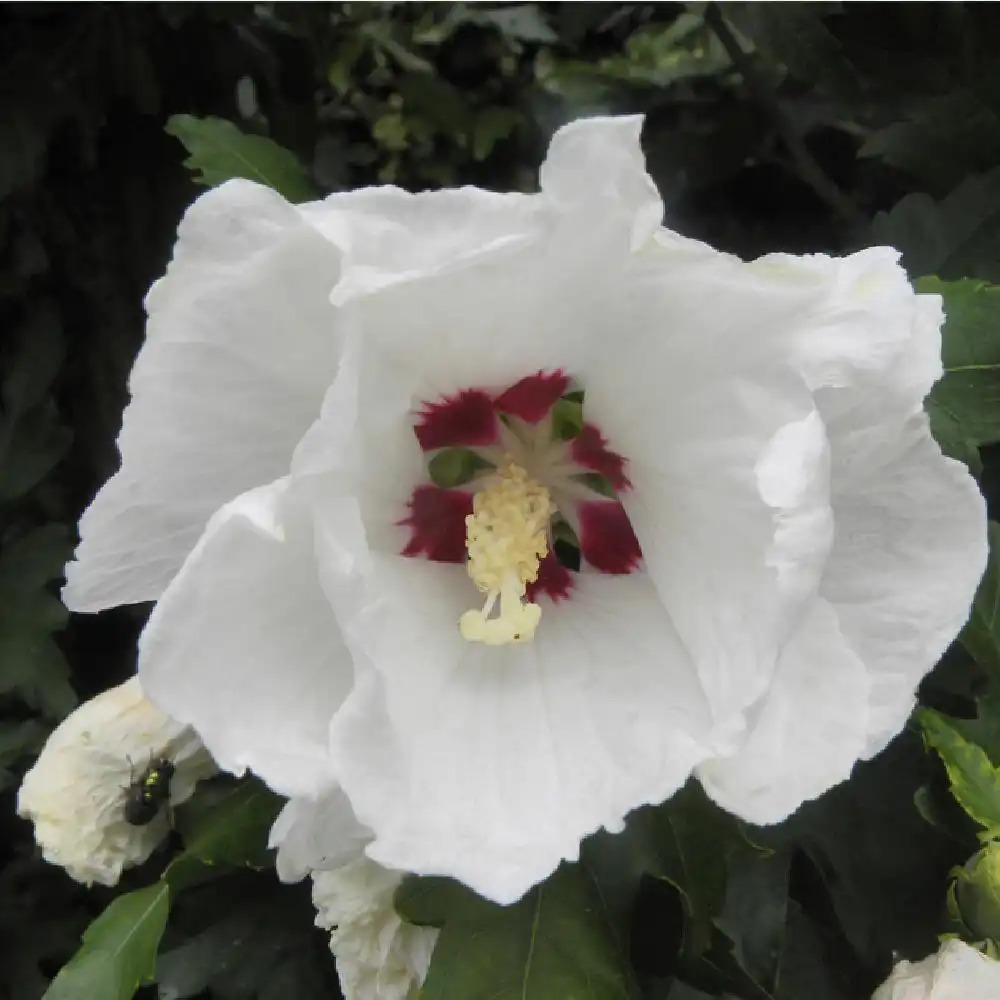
[43,882,170,1000]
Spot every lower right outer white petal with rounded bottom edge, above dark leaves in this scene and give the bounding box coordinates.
[697,600,869,824]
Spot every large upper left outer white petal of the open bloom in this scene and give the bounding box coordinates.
[63,181,339,611]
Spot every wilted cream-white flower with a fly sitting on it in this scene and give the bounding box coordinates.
[17,677,217,885]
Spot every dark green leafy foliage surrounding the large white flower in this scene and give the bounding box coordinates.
[0,3,1000,1000]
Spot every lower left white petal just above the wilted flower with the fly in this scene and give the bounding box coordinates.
[139,480,352,795]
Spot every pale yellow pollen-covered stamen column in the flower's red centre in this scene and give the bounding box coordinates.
[459,456,554,646]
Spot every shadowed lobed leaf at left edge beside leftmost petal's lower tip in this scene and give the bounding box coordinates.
[0,524,76,719]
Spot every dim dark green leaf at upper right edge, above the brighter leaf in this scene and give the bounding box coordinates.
[872,168,1000,281]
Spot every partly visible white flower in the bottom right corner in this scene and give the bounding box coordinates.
[872,939,1000,1000]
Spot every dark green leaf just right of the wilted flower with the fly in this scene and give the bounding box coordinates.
[164,778,284,888]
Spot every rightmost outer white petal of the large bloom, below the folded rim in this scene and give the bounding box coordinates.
[820,410,987,756]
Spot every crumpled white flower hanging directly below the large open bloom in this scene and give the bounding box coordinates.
[270,788,438,1000]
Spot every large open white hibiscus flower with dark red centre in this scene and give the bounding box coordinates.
[65,118,986,902]
